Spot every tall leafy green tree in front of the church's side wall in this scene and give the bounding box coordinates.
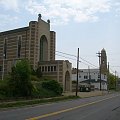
[9,59,33,97]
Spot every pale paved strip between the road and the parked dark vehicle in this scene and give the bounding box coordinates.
[63,91,108,98]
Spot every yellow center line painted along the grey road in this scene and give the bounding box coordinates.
[26,95,120,120]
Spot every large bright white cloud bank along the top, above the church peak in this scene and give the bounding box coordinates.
[26,0,111,24]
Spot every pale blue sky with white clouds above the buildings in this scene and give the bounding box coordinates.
[0,0,120,77]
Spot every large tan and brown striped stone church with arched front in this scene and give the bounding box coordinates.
[0,14,72,91]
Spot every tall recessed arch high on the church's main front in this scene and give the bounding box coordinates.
[40,35,48,61]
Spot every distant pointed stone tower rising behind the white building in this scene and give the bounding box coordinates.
[101,48,107,74]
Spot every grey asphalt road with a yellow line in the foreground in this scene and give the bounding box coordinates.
[0,93,120,120]
